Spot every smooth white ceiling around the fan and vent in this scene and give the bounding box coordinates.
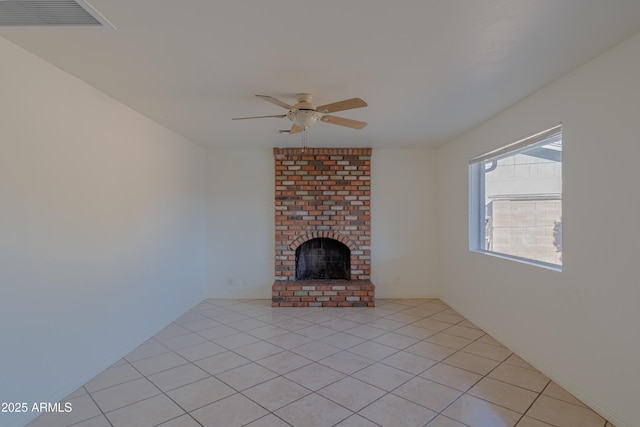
[0,0,640,148]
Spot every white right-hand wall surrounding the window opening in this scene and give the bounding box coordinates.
[438,30,640,427]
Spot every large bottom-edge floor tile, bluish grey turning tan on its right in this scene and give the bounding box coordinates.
[443,395,521,427]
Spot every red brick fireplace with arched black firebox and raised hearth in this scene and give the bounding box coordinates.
[272,148,375,307]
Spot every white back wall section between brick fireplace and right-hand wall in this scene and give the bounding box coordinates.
[371,149,439,298]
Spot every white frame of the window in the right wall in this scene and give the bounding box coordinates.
[468,123,564,272]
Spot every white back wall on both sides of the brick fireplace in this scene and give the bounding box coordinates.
[207,149,438,298]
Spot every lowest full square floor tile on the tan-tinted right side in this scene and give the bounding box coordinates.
[467,378,538,414]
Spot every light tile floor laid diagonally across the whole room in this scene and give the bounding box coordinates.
[23,299,613,427]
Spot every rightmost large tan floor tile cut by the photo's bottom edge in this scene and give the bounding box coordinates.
[526,395,605,427]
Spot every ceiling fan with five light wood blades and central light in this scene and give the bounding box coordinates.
[232,93,367,134]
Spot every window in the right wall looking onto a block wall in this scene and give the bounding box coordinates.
[469,125,562,269]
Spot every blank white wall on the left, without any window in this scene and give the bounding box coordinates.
[0,38,206,426]
